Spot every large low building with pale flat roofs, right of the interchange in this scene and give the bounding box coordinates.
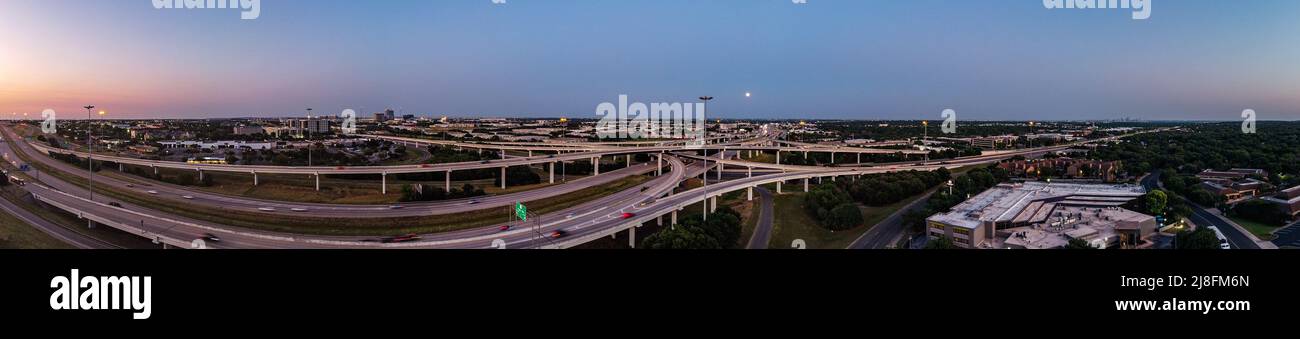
[926,182,1158,249]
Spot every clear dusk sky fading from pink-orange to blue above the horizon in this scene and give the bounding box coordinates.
[0,0,1300,121]
